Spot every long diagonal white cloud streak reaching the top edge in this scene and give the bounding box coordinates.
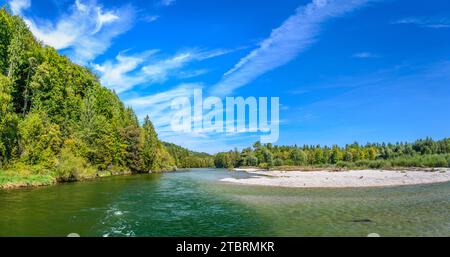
[211,0,371,95]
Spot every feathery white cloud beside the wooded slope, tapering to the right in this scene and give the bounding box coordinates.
[93,50,236,93]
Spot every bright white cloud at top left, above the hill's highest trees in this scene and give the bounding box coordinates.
[9,0,134,64]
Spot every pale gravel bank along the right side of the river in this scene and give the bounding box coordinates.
[221,168,450,188]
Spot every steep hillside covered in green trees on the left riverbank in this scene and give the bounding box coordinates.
[0,7,212,185]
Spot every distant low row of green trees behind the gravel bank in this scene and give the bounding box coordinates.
[214,138,450,169]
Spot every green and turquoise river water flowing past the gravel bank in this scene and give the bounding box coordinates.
[0,169,450,236]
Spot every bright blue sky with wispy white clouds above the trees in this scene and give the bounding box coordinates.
[0,0,450,153]
